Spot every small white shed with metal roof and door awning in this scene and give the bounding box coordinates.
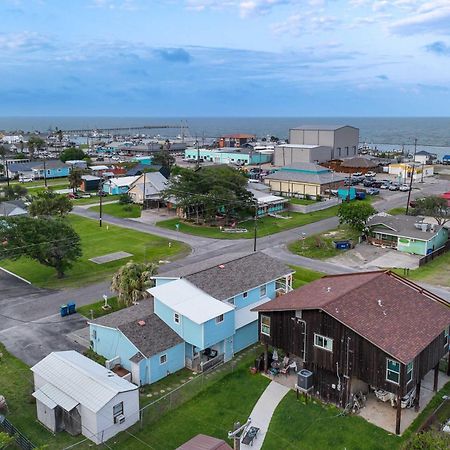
[31,350,139,444]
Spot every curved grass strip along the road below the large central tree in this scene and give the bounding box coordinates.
[156,206,338,239]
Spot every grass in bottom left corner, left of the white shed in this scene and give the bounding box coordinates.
[0,344,88,450]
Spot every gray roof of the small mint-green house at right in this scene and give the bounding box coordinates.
[367,215,442,241]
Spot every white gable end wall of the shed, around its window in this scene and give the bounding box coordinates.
[93,388,139,443]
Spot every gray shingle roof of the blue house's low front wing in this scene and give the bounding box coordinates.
[119,314,184,358]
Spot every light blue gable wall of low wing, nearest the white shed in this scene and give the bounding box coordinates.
[89,324,139,372]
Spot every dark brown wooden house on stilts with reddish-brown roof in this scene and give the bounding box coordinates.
[255,271,450,434]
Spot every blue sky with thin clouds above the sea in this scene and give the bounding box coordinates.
[0,0,450,117]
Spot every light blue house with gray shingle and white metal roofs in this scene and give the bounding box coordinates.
[90,252,293,385]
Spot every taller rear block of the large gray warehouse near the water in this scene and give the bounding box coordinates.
[286,125,359,164]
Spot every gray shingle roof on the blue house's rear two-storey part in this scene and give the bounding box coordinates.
[184,252,293,300]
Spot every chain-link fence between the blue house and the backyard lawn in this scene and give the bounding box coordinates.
[140,345,262,428]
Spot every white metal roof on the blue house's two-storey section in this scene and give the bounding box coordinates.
[148,279,234,324]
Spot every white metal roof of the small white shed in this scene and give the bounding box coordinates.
[31,350,138,412]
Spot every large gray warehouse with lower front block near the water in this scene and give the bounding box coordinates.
[274,125,359,166]
